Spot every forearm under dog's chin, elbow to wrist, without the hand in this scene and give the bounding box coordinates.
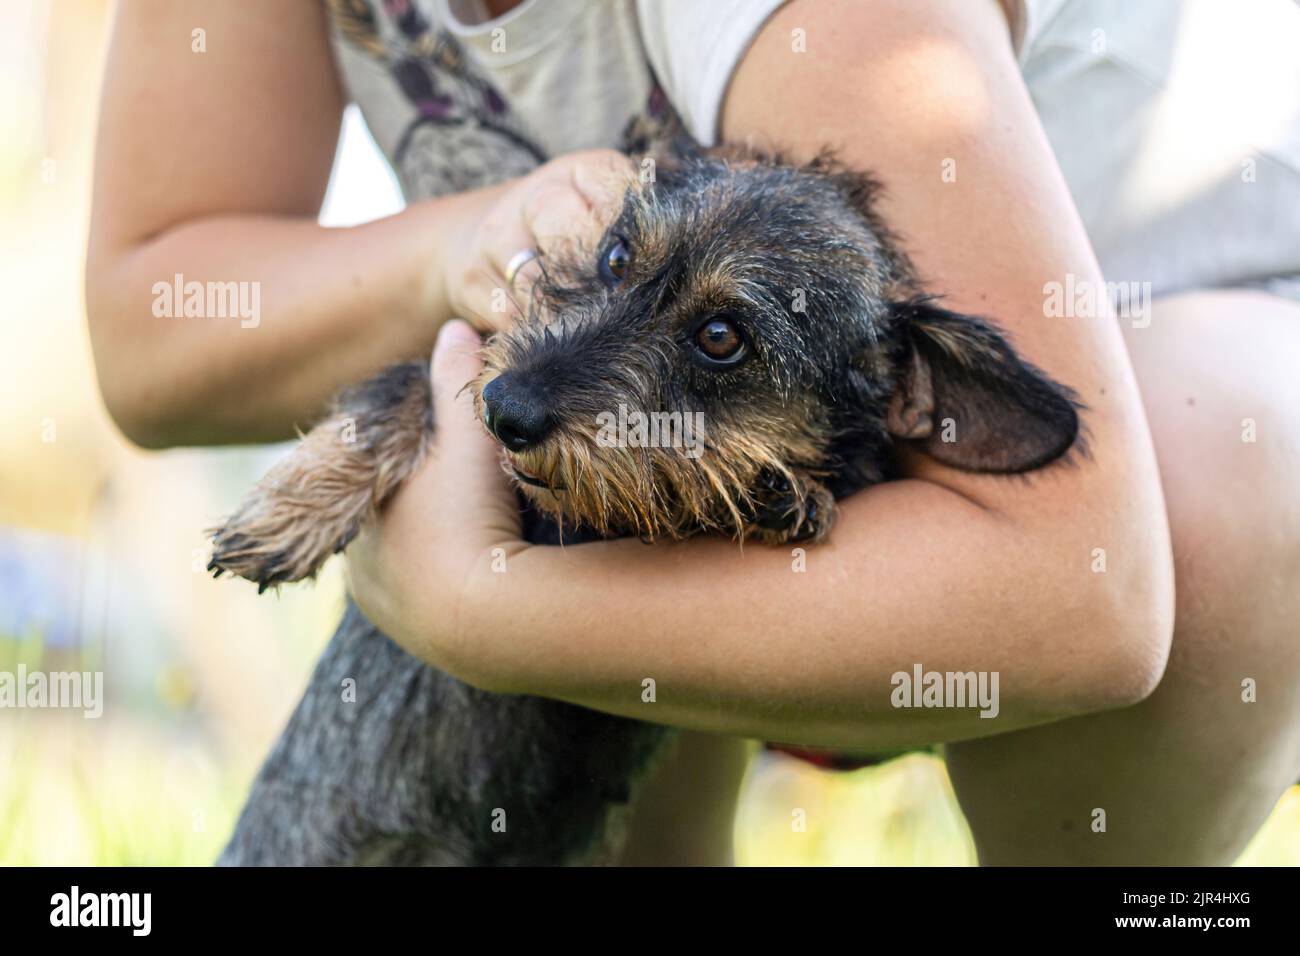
[452,475,1166,748]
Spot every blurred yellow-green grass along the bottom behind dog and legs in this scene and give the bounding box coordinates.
[0,711,1300,866]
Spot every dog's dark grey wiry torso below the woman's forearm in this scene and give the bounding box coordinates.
[221,604,672,866]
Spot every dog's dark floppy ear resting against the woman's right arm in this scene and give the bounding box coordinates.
[887,297,1083,473]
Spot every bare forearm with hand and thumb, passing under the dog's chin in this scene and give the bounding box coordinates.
[348,335,1173,748]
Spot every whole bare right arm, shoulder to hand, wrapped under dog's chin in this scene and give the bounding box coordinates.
[350,0,1173,748]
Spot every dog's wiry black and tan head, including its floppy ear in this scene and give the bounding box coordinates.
[476,147,1078,540]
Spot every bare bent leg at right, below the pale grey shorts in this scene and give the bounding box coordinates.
[948,293,1300,865]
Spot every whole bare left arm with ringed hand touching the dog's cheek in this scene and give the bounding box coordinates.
[86,0,621,447]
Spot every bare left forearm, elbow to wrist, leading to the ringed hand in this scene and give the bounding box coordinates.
[87,190,495,447]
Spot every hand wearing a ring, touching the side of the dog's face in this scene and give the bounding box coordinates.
[442,150,633,332]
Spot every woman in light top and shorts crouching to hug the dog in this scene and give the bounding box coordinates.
[87,0,1300,864]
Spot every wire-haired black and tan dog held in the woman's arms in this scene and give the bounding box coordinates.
[212,141,1079,864]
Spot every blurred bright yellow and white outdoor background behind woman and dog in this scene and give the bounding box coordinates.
[0,0,1300,865]
